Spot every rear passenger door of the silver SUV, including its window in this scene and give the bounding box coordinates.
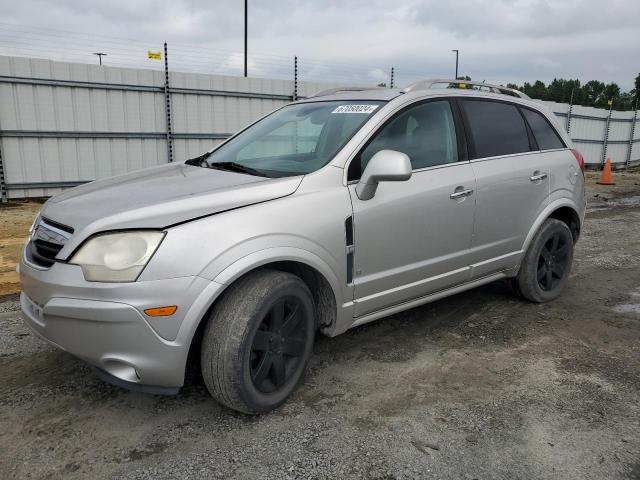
[459,99,551,278]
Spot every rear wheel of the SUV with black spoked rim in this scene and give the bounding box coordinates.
[514,218,573,303]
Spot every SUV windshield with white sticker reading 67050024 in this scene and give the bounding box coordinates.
[198,100,383,177]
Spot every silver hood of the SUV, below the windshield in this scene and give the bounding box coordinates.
[42,163,302,253]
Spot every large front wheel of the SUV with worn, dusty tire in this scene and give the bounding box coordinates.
[200,270,316,414]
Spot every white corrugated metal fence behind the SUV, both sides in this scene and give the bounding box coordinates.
[0,51,640,200]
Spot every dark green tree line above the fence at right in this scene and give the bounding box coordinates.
[507,73,640,111]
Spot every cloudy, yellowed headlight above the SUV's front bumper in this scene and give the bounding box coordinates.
[69,231,164,282]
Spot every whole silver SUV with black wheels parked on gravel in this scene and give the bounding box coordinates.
[19,80,585,413]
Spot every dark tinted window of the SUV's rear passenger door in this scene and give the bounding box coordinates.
[461,100,531,158]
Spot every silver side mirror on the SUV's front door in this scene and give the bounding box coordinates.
[356,150,411,200]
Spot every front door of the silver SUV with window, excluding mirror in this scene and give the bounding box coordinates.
[349,99,476,317]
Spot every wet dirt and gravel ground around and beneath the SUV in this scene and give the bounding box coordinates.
[0,174,640,480]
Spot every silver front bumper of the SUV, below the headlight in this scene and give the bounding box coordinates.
[19,256,222,393]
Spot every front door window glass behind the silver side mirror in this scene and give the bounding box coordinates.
[349,100,458,180]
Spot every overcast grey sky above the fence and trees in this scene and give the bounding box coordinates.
[0,0,640,90]
